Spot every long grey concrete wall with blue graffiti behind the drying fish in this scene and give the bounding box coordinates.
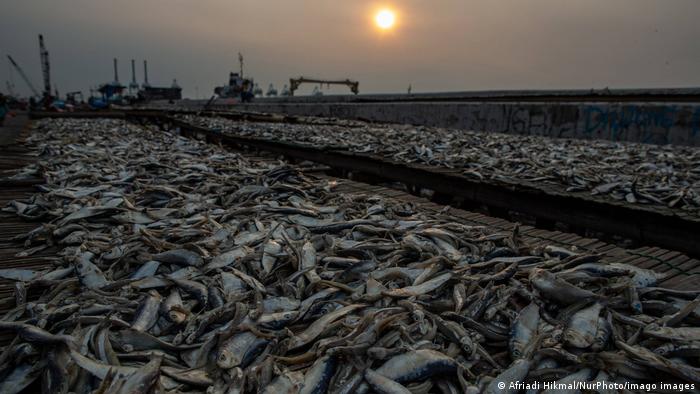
[226,102,700,146]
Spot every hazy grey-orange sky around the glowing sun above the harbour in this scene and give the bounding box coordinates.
[0,0,700,97]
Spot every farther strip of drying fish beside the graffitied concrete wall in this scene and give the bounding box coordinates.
[179,115,700,216]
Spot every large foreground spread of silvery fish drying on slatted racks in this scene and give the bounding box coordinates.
[0,120,700,394]
